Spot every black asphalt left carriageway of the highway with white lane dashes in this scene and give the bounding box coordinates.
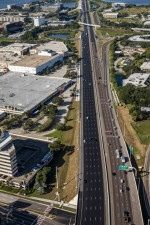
[76,2,105,225]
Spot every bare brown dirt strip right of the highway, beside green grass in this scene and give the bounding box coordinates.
[117,107,147,166]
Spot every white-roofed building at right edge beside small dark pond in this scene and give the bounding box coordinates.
[123,73,150,87]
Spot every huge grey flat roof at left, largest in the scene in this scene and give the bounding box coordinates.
[0,72,70,111]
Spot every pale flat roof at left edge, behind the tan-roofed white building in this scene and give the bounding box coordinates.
[0,43,36,51]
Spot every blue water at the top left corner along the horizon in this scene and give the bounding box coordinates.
[0,0,39,9]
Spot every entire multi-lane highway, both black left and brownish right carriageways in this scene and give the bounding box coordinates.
[76,0,143,225]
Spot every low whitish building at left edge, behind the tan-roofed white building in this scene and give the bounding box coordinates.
[0,43,36,55]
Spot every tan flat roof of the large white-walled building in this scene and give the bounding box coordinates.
[12,54,58,68]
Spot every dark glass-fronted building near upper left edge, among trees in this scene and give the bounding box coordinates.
[4,21,23,33]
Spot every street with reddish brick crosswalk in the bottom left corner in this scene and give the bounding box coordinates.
[0,193,75,225]
